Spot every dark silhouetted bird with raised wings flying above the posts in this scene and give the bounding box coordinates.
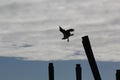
[59,26,74,42]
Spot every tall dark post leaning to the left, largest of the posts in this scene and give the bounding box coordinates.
[82,36,101,80]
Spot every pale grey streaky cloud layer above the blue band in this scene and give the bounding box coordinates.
[0,0,120,79]
